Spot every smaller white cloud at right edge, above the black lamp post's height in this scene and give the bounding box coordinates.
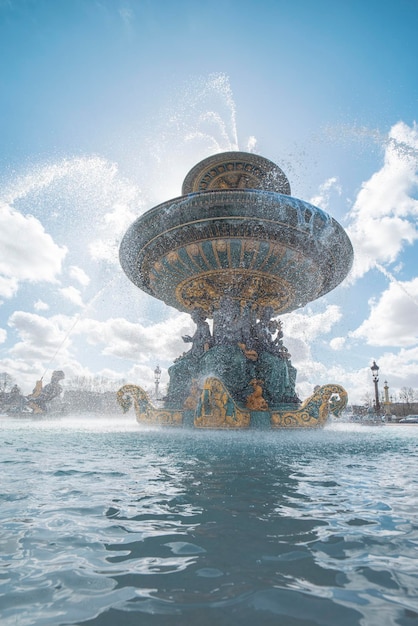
[350,278,418,348]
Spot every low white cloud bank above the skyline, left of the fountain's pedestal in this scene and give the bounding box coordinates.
[0,311,194,393]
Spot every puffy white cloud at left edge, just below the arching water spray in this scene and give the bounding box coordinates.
[0,203,67,298]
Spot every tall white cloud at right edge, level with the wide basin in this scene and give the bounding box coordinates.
[347,122,418,280]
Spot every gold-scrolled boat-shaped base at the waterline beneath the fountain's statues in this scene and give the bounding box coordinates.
[117,377,347,429]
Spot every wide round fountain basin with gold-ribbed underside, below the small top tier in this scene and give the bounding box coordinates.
[120,189,353,317]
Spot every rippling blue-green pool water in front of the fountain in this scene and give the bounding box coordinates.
[0,415,418,626]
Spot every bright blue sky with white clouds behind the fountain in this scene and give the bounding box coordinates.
[0,0,418,404]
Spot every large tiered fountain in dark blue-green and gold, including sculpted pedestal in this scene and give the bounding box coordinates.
[117,151,353,428]
